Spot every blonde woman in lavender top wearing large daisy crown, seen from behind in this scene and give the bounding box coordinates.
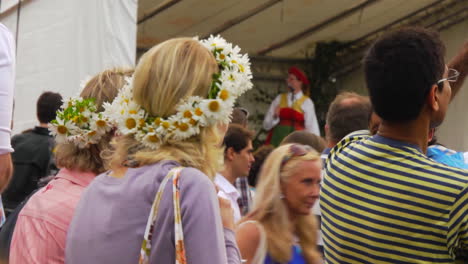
[66,37,252,264]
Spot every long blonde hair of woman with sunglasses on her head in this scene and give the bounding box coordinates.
[246,144,320,264]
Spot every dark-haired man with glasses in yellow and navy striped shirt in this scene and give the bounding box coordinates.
[320,28,468,264]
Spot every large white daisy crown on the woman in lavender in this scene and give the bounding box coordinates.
[104,36,253,149]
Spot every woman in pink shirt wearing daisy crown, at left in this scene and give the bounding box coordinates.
[9,69,132,264]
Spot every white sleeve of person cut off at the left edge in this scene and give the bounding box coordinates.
[0,23,15,155]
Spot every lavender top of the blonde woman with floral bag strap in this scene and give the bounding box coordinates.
[65,161,241,264]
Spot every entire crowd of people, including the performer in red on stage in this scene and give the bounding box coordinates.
[0,21,468,264]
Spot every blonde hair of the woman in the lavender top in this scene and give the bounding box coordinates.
[110,38,223,178]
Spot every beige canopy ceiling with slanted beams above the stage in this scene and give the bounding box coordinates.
[138,0,468,58]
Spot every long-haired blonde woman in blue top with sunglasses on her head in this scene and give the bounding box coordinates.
[236,144,321,264]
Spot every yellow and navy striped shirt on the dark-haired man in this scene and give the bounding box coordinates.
[320,131,468,264]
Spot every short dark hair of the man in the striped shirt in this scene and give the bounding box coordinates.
[364,27,445,122]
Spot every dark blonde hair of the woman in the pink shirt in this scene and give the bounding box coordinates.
[55,68,133,174]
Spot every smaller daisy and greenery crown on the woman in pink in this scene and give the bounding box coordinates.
[49,94,113,148]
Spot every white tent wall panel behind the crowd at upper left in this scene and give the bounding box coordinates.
[0,0,137,133]
